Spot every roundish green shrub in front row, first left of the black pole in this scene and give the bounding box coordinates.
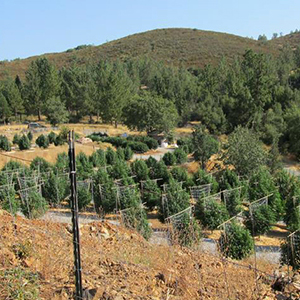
[21,189,47,219]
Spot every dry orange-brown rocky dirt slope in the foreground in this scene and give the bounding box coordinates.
[0,211,298,300]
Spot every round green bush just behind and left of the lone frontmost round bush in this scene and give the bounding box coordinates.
[195,199,229,230]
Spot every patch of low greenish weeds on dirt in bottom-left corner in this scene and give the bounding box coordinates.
[0,267,40,300]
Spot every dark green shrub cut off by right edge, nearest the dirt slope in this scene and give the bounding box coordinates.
[280,232,300,270]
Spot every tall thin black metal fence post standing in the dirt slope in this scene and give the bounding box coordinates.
[69,131,83,300]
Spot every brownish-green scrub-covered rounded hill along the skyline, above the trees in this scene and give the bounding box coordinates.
[0,28,283,79]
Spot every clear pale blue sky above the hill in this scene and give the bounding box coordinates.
[0,0,300,60]
